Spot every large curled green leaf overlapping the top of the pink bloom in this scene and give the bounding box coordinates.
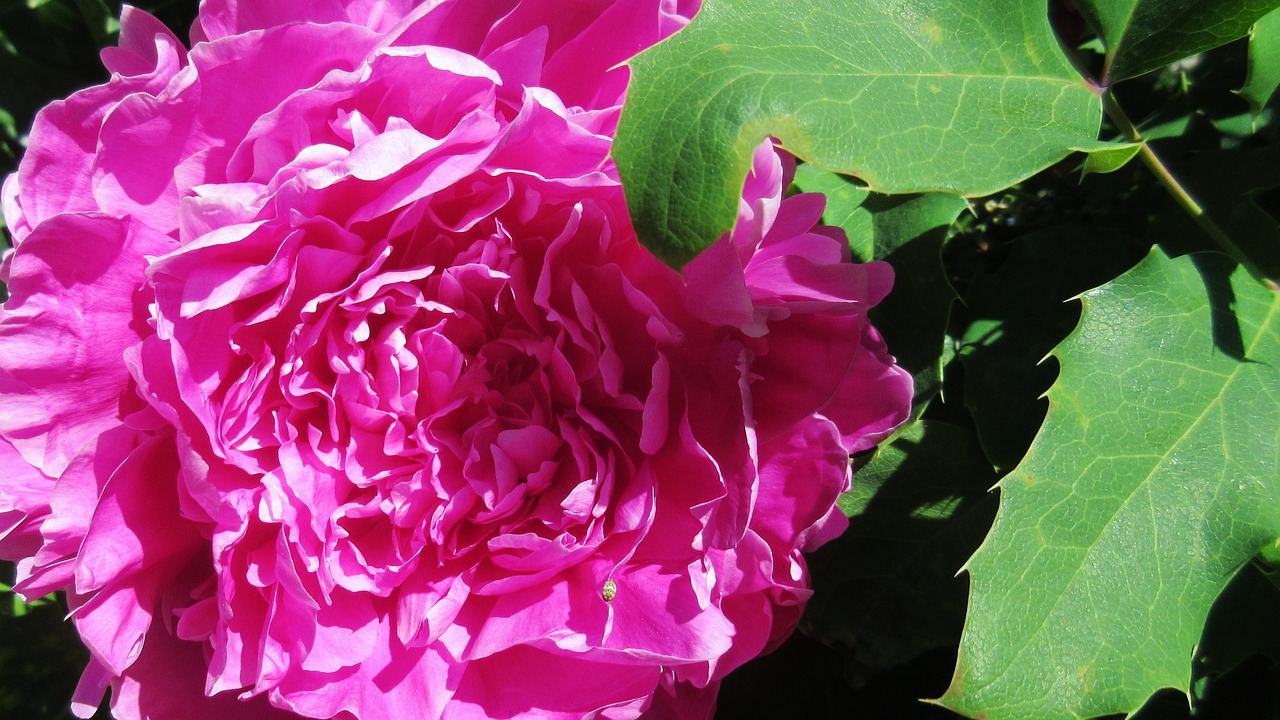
[614,0,1101,265]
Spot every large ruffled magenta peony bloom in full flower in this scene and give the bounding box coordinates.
[0,0,911,720]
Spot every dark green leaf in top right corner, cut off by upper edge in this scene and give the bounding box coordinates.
[1076,0,1280,85]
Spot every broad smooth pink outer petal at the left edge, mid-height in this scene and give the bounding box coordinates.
[0,215,172,477]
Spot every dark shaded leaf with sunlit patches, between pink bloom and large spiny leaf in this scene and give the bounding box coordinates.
[804,421,996,678]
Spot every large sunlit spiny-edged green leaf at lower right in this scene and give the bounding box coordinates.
[940,251,1280,720]
